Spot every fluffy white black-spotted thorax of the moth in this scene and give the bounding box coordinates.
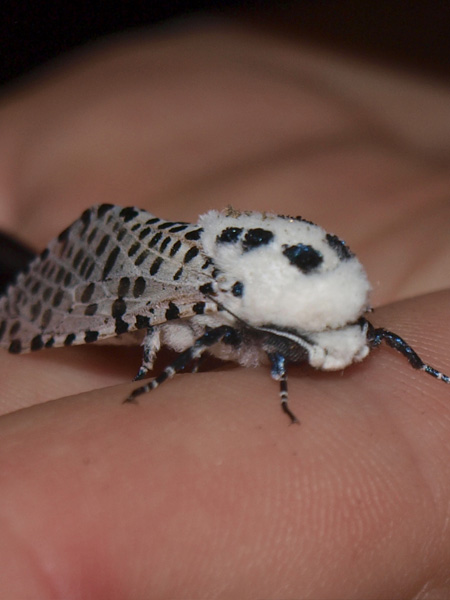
[199,211,370,332]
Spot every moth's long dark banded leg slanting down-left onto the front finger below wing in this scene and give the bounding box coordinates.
[124,325,235,402]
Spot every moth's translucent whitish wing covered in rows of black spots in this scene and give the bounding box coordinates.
[0,204,216,352]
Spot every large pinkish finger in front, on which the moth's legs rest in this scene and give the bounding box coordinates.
[0,294,450,599]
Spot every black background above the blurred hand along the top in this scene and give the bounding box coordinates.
[0,0,450,84]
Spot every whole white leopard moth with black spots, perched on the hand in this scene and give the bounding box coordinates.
[0,204,450,422]
